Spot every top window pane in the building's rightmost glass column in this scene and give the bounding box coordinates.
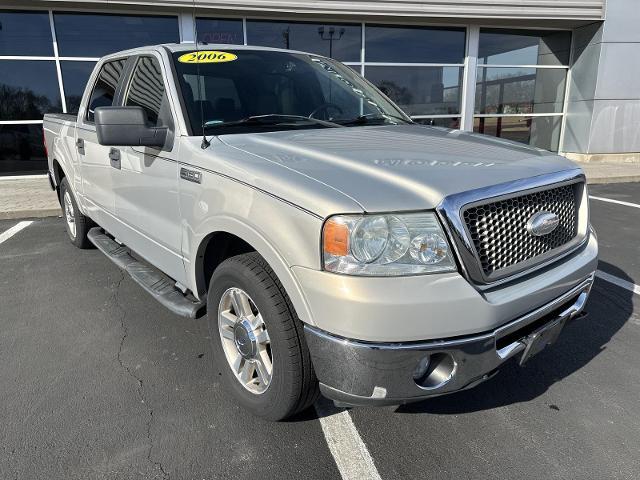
[478,28,571,65]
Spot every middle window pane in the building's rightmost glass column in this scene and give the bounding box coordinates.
[475,67,566,114]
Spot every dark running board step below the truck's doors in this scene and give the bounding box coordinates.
[87,227,205,318]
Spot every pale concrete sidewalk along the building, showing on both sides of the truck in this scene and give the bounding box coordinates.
[0,162,640,220]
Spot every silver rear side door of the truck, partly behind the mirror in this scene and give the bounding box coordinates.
[76,58,127,229]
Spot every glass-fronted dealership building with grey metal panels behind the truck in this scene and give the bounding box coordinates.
[0,0,640,176]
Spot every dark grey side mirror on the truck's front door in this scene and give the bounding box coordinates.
[94,107,169,148]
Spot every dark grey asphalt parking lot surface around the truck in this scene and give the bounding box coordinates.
[0,184,640,480]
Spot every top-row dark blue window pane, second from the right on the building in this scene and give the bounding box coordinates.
[365,25,465,63]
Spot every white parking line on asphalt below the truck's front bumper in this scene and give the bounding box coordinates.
[315,402,381,480]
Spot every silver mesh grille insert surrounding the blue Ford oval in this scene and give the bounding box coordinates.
[463,184,578,277]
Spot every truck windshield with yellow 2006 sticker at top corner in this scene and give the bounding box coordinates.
[173,47,411,135]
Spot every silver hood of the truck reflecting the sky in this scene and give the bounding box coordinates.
[219,125,576,212]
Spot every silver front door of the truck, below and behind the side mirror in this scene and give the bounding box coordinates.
[113,53,185,283]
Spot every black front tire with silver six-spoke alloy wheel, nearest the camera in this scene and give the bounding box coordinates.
[207,252,319,421]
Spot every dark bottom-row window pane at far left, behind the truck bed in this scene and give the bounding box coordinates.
[0,124,47,176]
